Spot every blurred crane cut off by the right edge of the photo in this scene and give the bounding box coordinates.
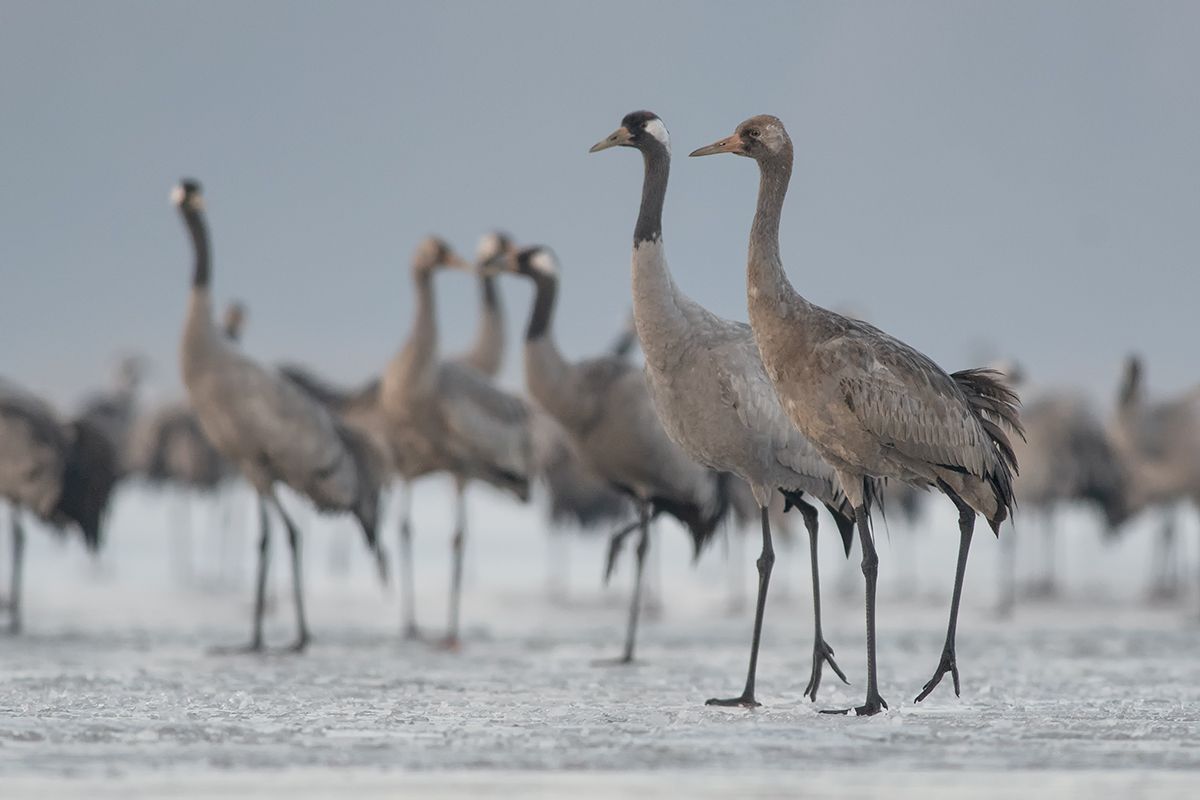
[1109,356,1200,599]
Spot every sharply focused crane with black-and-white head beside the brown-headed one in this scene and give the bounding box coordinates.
[592,112,854,706]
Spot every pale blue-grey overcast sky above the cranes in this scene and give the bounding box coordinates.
[0,0,1200,407]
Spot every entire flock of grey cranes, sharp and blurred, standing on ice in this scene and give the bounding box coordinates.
[0,112,1200,716]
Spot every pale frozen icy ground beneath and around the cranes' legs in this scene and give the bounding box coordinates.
[0,483,1200,798]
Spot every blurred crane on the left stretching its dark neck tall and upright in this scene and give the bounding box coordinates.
[172,180,386,651]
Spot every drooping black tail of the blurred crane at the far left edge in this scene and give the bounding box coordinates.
[54,420,120,553]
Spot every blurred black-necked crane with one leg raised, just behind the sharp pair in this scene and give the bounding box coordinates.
[484,247,728,663]
